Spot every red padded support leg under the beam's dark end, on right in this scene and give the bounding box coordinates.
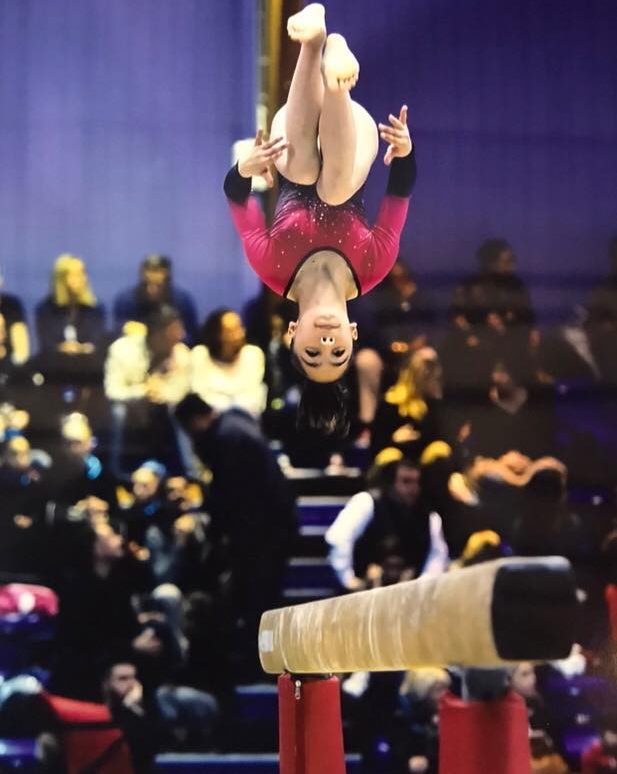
[439,692,531,774]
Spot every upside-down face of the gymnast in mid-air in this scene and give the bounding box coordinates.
[288,307,358,383]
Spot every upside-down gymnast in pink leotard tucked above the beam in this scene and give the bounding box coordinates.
[224,3,416,435]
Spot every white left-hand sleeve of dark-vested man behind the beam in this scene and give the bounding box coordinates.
[326,492,375,590]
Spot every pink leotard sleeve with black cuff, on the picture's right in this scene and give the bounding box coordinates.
[362,147,417,293]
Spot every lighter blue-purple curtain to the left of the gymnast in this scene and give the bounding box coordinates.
[0,0,257,328]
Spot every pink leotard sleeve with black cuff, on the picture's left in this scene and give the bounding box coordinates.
[223,164,269,276]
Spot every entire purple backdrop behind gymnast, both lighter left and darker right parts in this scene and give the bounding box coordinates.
[0,0,617,328]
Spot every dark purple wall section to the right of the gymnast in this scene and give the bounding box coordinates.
[328,0,617,318]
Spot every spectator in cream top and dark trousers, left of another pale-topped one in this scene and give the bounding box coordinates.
[105,306,191,477]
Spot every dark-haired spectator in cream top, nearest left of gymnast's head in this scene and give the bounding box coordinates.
[191,309,267,416]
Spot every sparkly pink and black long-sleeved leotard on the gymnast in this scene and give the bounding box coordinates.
[225,151,416,296]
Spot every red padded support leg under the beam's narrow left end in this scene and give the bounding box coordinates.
[278,674,345,774]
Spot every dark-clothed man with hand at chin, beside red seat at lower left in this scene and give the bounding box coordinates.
[102,660,159,774]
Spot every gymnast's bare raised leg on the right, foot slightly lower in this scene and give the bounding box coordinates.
[317,35,379,205]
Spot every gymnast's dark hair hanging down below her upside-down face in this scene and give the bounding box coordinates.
[290,340,350,438]
